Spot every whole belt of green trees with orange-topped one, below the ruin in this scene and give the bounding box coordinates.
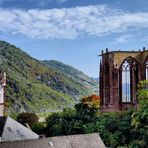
[17,82,148,148]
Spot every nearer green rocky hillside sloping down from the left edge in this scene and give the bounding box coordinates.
[0,41,98,115]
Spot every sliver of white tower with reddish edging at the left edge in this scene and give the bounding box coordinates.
[0,73,6,117]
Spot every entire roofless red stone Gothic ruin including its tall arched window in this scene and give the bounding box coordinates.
[99,48,148,111]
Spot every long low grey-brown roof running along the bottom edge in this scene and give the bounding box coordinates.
[0,133,105,148]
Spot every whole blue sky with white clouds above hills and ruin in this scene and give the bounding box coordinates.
[0,0,148,77]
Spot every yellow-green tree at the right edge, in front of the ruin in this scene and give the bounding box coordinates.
[131,80,148,147]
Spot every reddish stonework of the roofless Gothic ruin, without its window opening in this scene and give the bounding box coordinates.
[100,48,148,111]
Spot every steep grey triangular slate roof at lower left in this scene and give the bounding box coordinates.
[0,117,39,141]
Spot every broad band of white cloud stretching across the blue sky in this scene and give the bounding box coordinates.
[0,5,148,39]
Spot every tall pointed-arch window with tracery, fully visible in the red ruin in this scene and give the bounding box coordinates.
[122,60,131,102]
